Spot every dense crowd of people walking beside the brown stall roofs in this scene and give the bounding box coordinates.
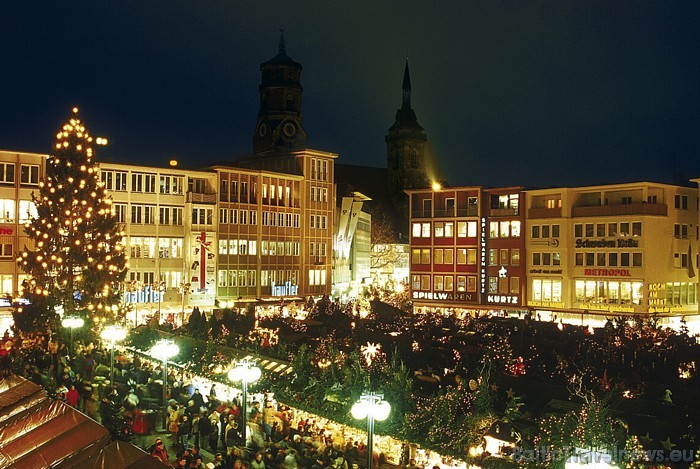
[0,333,394,469]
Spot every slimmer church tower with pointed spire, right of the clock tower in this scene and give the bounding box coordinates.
[384,60,429,218]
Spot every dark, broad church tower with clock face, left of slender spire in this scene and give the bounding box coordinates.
[253,31,306,154]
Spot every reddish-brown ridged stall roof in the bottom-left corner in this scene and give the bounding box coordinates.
[0,376,111,468]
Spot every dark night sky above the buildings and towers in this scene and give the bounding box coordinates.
[0,0,700,186]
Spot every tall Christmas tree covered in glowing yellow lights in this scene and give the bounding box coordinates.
[18,108,126,327]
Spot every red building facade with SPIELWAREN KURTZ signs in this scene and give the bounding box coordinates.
[406,186,526,312]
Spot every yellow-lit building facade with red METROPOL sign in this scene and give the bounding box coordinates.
[526,182,698,317]
